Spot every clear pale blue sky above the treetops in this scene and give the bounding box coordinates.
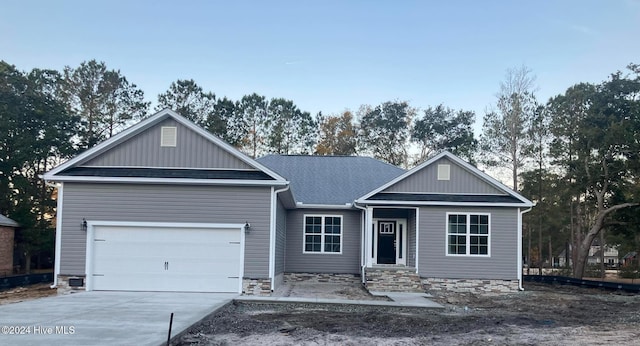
[0,0,640,126]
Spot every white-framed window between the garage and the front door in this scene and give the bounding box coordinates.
[303,215,342,253]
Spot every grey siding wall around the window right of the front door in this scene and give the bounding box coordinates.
[418,207,518,280]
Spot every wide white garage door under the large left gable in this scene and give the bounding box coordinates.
[90,226,241,292]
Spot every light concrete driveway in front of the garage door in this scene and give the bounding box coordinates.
[0,291,238,345]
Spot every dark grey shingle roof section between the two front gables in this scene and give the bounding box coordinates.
[257,155,405,205]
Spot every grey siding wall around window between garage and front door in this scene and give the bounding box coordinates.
[285,209,362,274]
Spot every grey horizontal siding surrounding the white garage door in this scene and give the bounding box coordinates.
[60,183,271,278]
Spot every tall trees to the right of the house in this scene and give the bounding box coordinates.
[479,64,640,277]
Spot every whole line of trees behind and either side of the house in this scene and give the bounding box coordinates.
[0,60,640,276]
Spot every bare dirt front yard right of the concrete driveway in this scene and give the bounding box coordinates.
[177,283,640,345]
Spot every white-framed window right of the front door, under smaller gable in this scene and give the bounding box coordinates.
[447,213,491,256]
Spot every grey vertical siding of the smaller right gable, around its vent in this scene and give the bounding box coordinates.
[382,157,505,195]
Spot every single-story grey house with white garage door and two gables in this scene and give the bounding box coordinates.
[44,110,532,294]
